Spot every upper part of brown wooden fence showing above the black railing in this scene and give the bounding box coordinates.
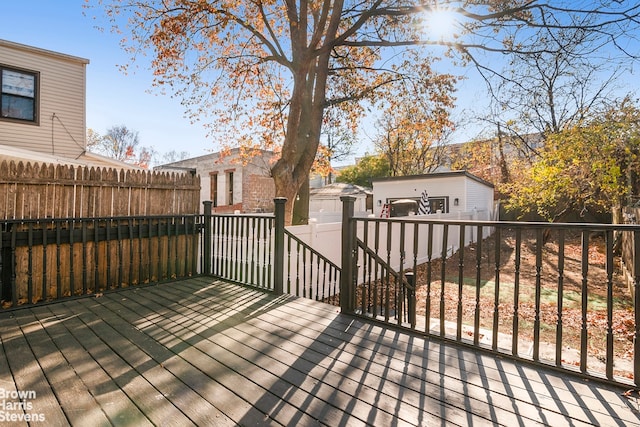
[0,161,200,219]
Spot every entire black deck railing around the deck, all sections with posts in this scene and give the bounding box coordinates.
[0,197,640,386]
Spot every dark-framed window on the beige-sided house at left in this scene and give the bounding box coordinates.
[0,66,38,123]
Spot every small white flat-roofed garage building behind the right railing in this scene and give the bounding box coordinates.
[372,171,494,219]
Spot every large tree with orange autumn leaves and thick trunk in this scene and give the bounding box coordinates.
[91,0,640,222]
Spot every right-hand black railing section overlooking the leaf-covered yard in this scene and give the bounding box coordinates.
[342,198,640,385]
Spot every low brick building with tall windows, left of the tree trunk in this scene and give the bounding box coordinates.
[154,148,276,213]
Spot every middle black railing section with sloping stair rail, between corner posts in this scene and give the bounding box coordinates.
[203,198,340,305]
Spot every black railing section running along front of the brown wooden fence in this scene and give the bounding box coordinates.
[0,215,201,308]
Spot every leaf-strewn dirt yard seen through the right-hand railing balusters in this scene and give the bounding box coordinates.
[416,232,635,377]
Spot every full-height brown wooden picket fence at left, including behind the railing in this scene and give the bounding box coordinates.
[0,161,200,307]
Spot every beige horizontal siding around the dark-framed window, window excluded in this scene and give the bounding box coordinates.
[0,40,89,159]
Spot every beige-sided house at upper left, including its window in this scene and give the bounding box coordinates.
[0,40,89,159]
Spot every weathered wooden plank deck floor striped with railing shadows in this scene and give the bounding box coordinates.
[0,278,640,427]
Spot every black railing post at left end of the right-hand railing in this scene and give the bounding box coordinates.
[340,196,356,313]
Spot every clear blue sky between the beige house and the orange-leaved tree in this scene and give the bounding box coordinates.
[0,0,216,161]
